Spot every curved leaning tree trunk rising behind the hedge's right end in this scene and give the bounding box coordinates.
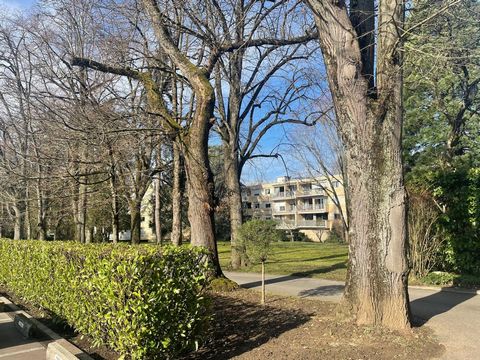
[143,0,223,276]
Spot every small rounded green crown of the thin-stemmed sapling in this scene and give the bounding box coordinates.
[239,220,282,263]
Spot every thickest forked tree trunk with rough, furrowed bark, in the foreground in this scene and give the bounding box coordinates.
[308,0,410,329]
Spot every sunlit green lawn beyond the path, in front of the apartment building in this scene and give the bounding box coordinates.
[218,241,348,281]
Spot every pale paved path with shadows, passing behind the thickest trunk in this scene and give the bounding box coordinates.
[225,272,480,360]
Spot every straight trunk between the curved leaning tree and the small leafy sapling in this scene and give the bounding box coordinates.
[223,141,243,269]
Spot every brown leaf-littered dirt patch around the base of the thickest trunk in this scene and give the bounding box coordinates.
[184,289,444,360]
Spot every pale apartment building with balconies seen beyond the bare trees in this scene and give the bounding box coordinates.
[242,176,346,241]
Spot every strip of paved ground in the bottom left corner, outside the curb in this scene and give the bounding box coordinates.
[0,313,47,360]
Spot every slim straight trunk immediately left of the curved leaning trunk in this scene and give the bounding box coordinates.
[171,142,182,246]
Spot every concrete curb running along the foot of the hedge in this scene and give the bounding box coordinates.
[0,296,93,360]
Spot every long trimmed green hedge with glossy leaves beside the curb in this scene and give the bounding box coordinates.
[0,239,209,359]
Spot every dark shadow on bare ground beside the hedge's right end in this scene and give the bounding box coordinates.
[184,295,313,360]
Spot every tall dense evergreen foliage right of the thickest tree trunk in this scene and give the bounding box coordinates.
[403,0,480,273]
